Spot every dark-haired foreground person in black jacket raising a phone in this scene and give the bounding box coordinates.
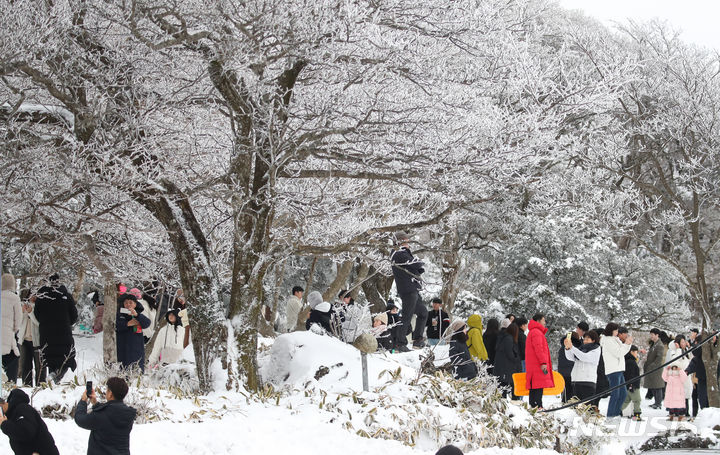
[75,378,136,455]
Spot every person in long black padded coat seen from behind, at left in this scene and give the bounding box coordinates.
[33,274,78,380]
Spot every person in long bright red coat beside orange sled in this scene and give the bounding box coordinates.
[525,313,555,409]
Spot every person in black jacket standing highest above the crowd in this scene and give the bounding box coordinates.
[390,232,428,352]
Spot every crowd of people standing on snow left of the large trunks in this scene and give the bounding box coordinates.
[1,273,190,386]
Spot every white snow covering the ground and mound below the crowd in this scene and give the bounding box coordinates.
[0,332,720,455]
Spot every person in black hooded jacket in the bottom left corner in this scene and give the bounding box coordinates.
[0,389,59,455]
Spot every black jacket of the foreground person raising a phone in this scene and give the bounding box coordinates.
[75,401,135,455]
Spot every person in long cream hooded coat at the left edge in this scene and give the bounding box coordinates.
[0,273,22,384]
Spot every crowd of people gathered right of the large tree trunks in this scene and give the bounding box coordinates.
[286,232,720,420]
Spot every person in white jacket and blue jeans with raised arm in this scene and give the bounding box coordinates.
[600,322,633,417]
